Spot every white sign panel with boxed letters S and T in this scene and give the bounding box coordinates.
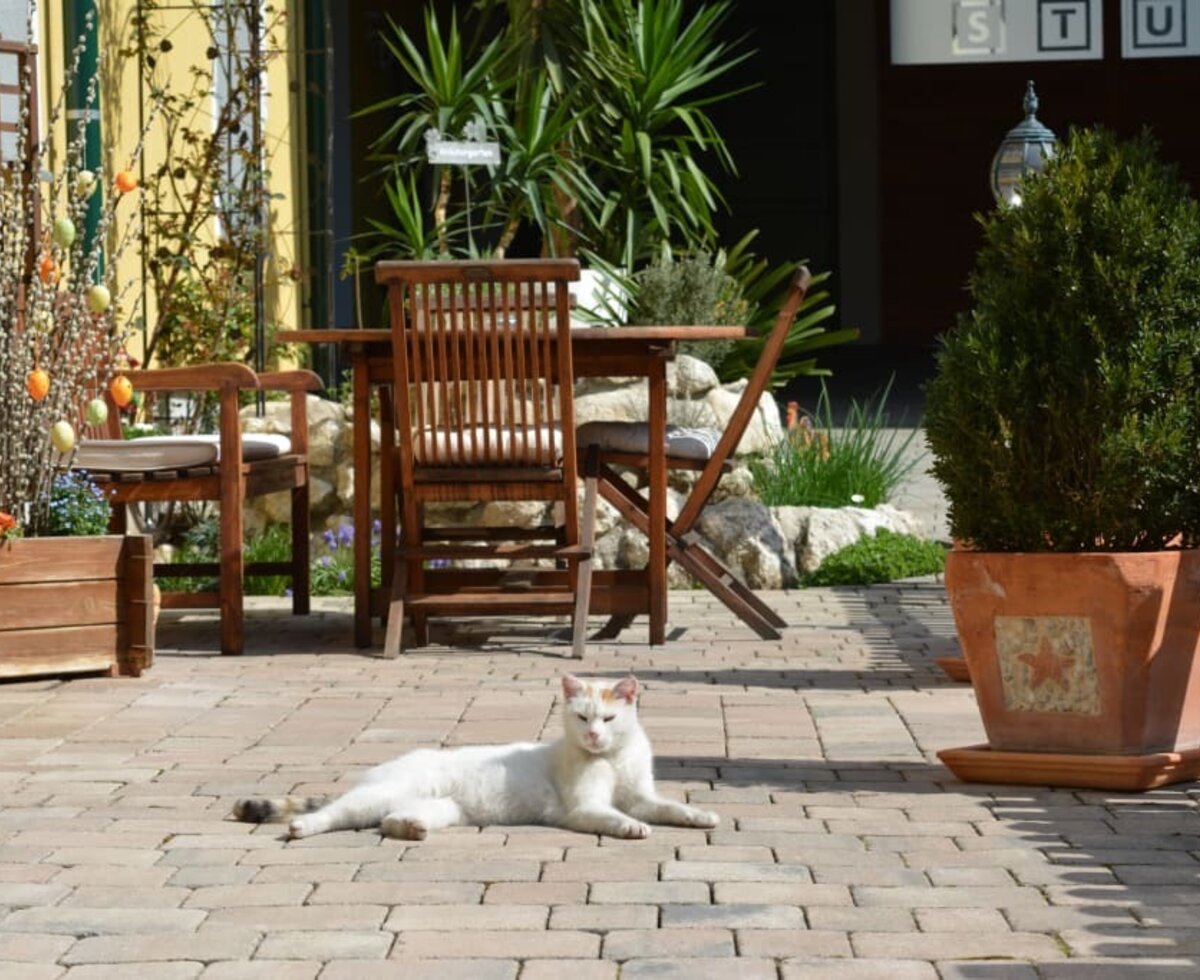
[892,0,1104,65]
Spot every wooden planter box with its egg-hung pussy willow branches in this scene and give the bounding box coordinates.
[0,4,154,678]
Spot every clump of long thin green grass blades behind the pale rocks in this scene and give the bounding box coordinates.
[749,381,919,507]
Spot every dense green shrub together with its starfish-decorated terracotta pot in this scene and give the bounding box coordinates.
[926,130,1200,789]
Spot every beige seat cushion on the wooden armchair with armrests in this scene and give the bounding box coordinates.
[72,433,292,473]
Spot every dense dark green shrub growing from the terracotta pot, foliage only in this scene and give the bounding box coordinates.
[925,128,1200,552]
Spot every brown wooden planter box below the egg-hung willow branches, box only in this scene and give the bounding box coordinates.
[0,535,154,679]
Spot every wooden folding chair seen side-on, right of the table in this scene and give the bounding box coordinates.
[576,266,811,639]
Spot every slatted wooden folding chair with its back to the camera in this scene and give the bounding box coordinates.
[376,259,588,656]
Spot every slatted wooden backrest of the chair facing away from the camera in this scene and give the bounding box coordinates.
[376,259,578,479]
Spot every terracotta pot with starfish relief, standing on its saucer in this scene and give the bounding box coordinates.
[940,551,1200,789]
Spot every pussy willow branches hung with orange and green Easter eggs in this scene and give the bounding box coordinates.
[0,0,152,535]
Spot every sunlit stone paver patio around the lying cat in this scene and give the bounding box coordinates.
[0,582,1200,980]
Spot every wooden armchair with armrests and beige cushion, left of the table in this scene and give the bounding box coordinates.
[79,363,322,654]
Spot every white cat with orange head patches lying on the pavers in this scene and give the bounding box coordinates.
[234,674,720,841]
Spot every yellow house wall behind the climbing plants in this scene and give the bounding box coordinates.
[40,0,304,356]
